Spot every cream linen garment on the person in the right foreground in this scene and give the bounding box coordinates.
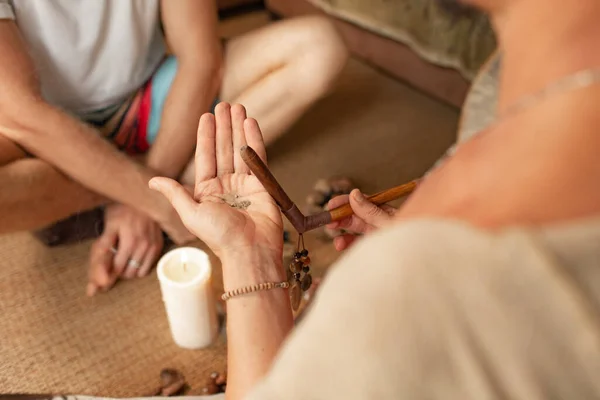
[247,220,600,400]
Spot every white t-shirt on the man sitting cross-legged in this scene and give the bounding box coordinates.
[0,0,166,115]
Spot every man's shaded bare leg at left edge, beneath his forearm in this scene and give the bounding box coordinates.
[0,135,103,234]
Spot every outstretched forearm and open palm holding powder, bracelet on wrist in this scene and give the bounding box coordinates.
[150,103,293,398]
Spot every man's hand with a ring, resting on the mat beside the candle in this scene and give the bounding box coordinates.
[87,204,163,295]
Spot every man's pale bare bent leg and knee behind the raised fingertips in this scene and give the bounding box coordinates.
[220,16,348,144]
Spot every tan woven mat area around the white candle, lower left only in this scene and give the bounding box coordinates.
[0,234,225,397]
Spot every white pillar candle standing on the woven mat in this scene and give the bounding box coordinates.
[157,247,218,349]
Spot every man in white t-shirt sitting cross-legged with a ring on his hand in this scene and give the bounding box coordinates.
[0,0,347,294]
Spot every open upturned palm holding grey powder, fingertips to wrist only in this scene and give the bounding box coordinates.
[150,103,283,260]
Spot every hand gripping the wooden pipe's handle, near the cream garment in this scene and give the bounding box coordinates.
[327,189,396,251]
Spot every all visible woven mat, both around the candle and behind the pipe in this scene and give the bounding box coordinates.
[0,30,458,397]
